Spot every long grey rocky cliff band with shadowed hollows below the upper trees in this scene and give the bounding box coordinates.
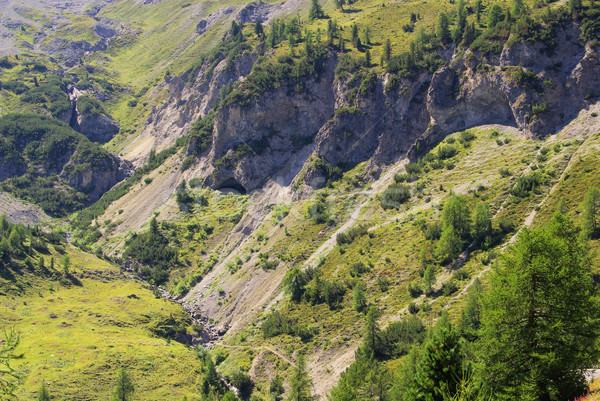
[130,22,600,197]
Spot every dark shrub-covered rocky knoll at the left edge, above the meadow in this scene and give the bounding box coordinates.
[0,114,113,216]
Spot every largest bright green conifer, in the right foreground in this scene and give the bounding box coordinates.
[480,215,600,400]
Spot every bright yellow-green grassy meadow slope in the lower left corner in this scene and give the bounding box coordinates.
[0,223,202,400]
